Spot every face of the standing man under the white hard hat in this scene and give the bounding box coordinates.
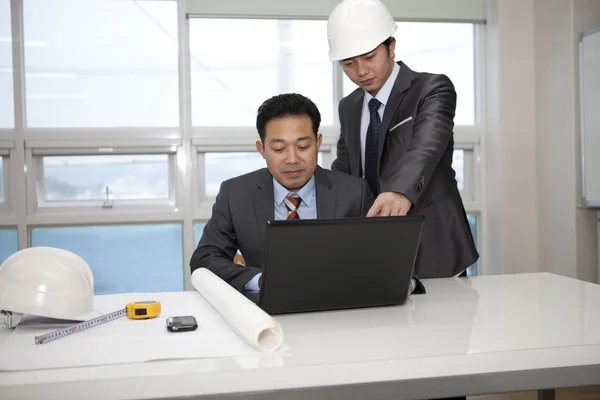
[340,39,396,96]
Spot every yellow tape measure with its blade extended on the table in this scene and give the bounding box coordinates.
[35,301,161,344]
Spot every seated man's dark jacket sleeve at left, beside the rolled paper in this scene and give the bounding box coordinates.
[190,182,261,292]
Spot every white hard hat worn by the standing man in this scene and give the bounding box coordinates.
[327,0,398,61]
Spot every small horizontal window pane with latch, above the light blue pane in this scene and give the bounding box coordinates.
[43,154,169,201]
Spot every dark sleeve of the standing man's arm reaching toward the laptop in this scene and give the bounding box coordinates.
[381,75,456,205]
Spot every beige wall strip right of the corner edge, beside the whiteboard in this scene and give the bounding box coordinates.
[534,0,577,277]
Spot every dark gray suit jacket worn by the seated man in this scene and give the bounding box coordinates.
[190,167,374,292]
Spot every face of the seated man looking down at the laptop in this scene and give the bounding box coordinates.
[256,115,322,192]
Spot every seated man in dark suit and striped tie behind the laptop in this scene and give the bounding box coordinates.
[190,94,423,292]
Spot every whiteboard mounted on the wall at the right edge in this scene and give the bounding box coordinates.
[579,27,600,208]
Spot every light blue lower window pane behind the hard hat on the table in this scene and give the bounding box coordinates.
[31,224,184,294]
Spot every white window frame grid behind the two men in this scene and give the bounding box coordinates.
[0,0,489,289]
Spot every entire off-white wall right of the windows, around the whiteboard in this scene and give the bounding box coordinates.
[486,0,600,282]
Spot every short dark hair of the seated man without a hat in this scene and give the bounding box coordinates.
[256,93,321,142]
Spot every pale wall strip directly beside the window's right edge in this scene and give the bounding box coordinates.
[484,0,539,274]
